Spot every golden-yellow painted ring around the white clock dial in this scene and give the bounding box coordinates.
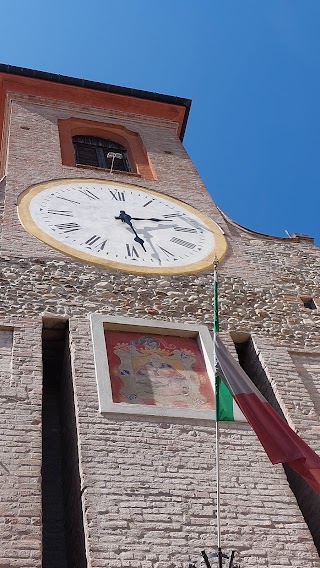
[17,178,227,276]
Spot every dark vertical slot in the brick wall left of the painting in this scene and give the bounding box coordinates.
[42,318,87,568]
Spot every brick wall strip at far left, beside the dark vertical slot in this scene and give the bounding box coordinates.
[0,318,42,568]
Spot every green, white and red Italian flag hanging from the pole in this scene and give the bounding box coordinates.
[214,270,320,495]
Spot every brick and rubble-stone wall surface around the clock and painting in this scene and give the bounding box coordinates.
[0,71,320,568]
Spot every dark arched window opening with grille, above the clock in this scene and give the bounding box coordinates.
[72,136,131,172]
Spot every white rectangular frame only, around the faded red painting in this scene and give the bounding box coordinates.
[90,314,215,420]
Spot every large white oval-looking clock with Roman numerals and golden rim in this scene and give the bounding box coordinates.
[18,179,226,274]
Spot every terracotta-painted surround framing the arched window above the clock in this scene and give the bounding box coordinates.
[58,118,156,180]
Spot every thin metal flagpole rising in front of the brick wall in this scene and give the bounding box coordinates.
[213,258,222,568]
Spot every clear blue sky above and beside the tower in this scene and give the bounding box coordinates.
[0,0,320,245]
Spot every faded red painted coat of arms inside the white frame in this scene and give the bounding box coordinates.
[106,332,213,409]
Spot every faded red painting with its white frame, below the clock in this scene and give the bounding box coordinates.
[91,314,215,419]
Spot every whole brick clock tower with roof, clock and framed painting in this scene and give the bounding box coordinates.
[0,65,320,568]
